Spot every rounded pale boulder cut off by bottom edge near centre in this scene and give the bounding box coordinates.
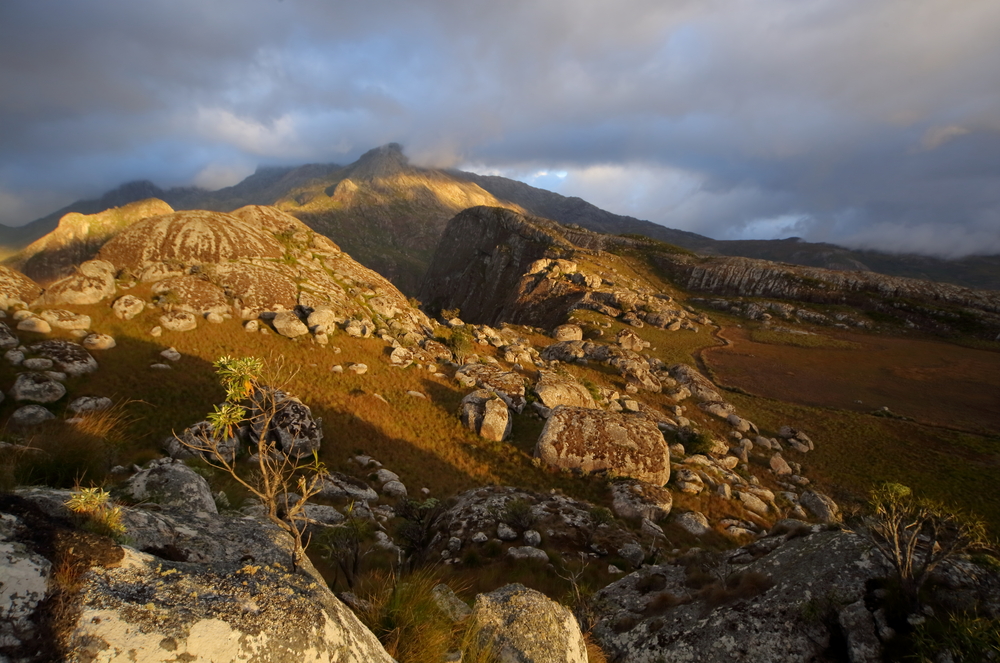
[470,584,587,663]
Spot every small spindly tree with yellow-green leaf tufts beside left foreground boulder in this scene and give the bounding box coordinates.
[174,356,326,570]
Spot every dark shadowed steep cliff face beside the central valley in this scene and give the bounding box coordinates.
[420,207,573,324]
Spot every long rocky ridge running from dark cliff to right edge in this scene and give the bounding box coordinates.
[421,208,1000,340]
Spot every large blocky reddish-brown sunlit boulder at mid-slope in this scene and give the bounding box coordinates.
[535,406,670,486]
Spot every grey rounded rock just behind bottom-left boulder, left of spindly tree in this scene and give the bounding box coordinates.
[124,458,219,513]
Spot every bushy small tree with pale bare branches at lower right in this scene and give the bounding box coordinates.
[868,483,987,605]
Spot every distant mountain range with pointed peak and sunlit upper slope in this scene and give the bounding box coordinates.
[7,143,1000,293]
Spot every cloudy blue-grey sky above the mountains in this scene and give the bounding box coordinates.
[0,0,1000,257]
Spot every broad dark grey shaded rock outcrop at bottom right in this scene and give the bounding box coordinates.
[593,531,887,663]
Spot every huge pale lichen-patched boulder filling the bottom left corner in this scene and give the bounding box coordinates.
[9,489,392,663]
